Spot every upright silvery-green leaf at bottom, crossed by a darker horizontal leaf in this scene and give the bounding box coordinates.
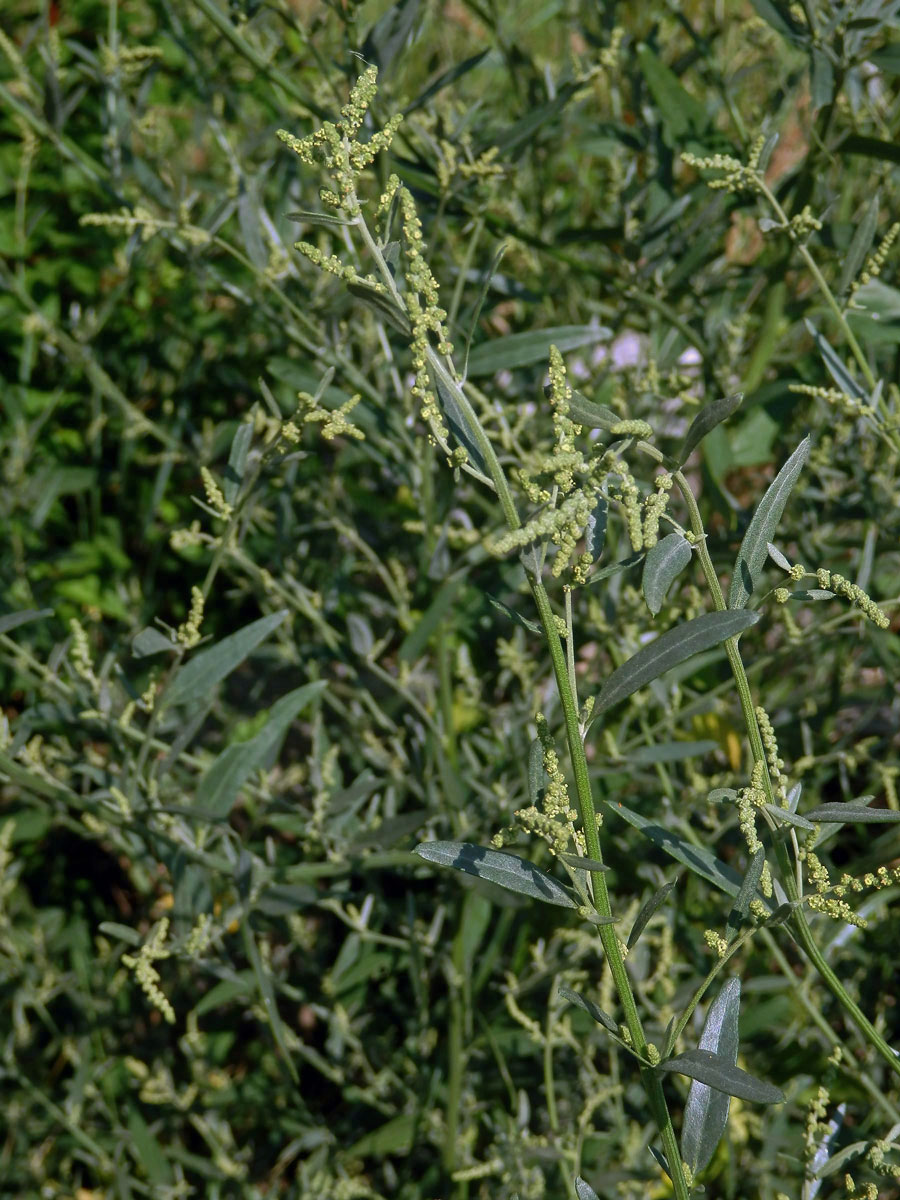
[682,979,740,1176]
